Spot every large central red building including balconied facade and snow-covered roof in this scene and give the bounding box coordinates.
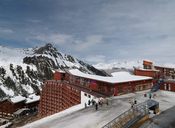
[39,69,152,117]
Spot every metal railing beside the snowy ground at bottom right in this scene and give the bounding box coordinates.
[102,101,149,128]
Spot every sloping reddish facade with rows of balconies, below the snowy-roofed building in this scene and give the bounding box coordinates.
[39,79,81,117]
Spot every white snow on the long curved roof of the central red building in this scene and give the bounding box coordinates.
[69,69,152,84]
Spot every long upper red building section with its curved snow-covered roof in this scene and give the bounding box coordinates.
[66,69,152,97]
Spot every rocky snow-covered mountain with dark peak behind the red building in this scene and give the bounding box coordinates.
[0,44,107,98]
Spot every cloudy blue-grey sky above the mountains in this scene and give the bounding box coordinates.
[0,0,175,64]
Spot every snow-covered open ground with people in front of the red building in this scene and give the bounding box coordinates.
[23,90,175,128]
